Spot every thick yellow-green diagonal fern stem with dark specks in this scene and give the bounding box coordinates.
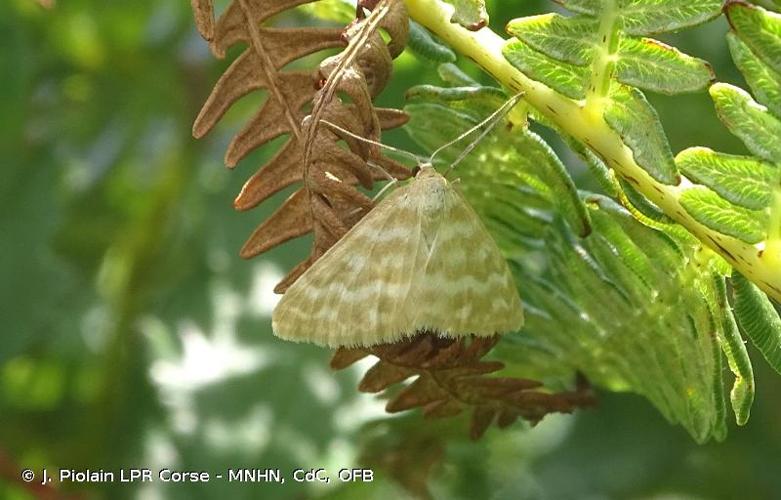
[404,0,781,301]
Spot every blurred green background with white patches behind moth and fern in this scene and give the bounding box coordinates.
[0,0,781,499]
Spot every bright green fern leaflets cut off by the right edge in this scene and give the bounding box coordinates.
[676,2,781,371]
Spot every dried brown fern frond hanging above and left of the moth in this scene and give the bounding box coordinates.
[192,0,409,292]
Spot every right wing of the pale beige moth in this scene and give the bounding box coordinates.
[411,185,523,337]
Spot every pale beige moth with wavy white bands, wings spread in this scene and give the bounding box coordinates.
[272,94,523,347]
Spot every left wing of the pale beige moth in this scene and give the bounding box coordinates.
[272,186,421,347]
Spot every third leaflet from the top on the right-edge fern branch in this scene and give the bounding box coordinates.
[710,83,781,162]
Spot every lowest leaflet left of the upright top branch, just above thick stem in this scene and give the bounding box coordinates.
[502,39,589,99]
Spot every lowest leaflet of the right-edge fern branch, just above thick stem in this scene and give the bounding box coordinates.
[681,187,768,244]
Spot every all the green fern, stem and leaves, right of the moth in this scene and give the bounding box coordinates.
[396,0,781,441]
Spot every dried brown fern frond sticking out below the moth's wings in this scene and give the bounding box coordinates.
[331,333,594,439]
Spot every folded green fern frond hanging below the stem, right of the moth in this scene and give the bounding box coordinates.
[406,86,754,442]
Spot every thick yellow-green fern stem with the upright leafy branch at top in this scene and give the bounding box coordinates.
[406,0,781,299]
